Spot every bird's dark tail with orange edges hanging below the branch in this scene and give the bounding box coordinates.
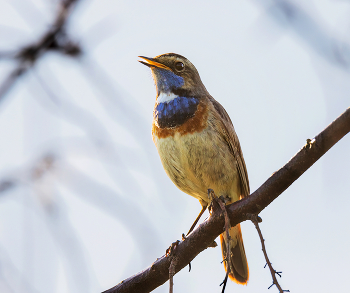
[220,224,249,285]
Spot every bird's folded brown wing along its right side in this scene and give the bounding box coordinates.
[209,96,250,197]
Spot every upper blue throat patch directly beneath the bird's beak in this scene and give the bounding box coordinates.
[152,68,185,95]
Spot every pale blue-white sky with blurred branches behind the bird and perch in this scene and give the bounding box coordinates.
[0,0,350,293]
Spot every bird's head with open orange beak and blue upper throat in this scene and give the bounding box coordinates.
[139,53,207,97]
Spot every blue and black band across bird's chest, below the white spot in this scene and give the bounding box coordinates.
[153,97,199,128]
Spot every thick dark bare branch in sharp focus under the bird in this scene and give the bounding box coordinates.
[104,108,350,293]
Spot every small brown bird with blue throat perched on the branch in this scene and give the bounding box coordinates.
[139,53,250,284]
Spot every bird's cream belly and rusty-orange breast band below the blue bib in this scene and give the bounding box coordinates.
[153,106,240,203]
